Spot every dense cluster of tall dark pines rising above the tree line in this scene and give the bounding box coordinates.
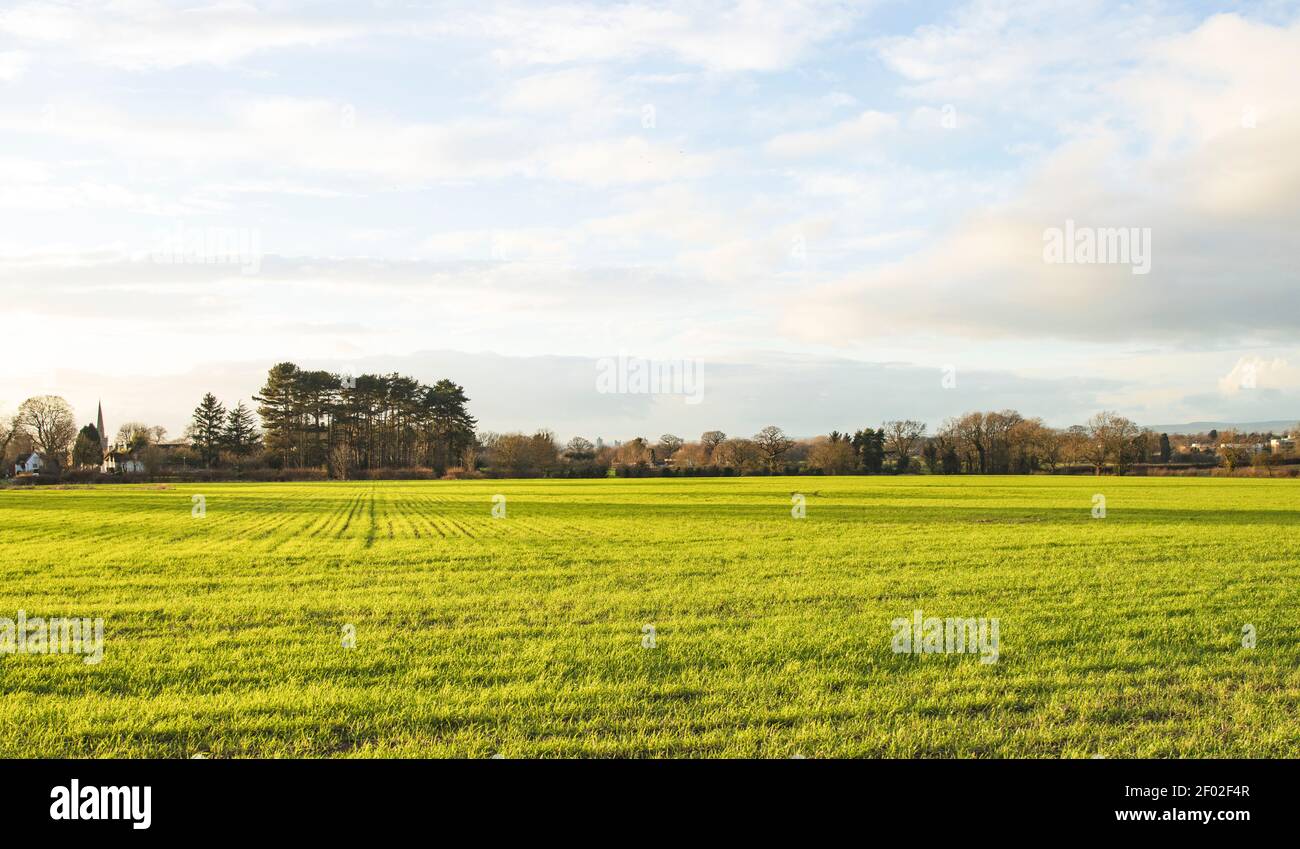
[255,363,477,476]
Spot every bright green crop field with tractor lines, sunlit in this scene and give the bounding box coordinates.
[0,477,1300,758]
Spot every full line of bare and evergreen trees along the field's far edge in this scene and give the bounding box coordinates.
[0,374,1296,478]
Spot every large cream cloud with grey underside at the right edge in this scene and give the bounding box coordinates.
[787,18,1300,343]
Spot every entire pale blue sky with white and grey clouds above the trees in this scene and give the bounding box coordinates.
[0,0,1300,439]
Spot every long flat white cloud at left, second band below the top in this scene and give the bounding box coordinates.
[0,98,714,186]
